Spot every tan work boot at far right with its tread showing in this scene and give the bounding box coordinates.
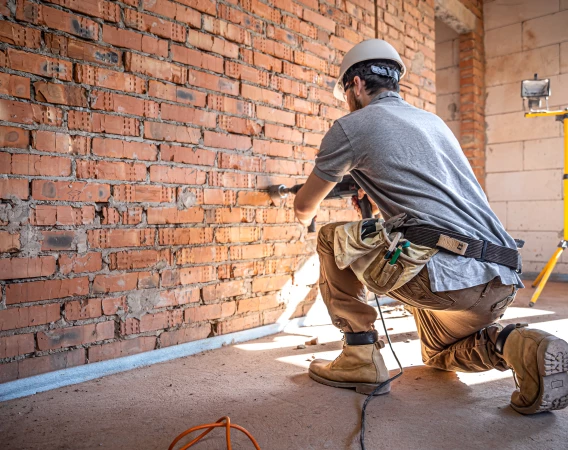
[495,324,568,414]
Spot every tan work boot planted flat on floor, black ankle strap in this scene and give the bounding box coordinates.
[309,330,390,395]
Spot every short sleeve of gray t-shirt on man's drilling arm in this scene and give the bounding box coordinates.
[314,121,354,183]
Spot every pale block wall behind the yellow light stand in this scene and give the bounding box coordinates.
[484,0,568,274]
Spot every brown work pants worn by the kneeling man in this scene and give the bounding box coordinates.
[317,223,516,372]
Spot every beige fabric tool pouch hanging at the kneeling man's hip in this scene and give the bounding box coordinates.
[334,215,438,294]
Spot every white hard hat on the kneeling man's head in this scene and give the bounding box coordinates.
[333,39,406,101]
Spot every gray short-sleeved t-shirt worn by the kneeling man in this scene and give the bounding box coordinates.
[314,92,523,292]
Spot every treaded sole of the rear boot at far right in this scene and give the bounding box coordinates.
[511,336,568,414]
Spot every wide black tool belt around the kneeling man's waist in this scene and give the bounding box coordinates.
[393,225,522,273]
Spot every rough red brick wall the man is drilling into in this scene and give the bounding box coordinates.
[0,0,442,381]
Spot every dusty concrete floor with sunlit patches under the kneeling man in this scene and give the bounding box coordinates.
[0,283,568,450]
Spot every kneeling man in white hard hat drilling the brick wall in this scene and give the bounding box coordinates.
[294,39,568,414]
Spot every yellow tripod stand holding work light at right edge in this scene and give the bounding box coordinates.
[525,108,568,306]
